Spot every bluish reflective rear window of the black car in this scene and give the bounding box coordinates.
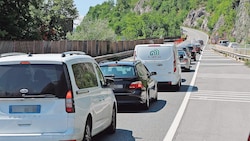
[101,65,135,77]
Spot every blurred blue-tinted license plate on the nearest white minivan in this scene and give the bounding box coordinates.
[9,105,41,114]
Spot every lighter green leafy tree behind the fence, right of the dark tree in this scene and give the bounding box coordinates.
[41,0,78,40]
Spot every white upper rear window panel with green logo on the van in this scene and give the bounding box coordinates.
[136,46,173,60]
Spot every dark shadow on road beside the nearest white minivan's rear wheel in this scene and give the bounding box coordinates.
[93,129,135,141]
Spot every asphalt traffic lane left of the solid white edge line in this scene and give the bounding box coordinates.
[93,27,206,141]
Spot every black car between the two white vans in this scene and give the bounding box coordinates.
[100,61,158,109]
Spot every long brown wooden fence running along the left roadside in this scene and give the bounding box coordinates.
[0,39,164,57]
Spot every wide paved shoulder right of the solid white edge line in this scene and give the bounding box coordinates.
[171,28,250,141]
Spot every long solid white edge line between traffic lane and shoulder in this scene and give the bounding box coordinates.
[163,28,208,141]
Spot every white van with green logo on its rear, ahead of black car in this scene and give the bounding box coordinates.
[134,43,181,91]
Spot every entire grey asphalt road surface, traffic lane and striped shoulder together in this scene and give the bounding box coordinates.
[94,28,250,141]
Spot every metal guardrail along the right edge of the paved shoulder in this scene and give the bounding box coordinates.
[212,45,250,60]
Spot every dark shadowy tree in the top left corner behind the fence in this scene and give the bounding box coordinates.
[0,0,39,40]
